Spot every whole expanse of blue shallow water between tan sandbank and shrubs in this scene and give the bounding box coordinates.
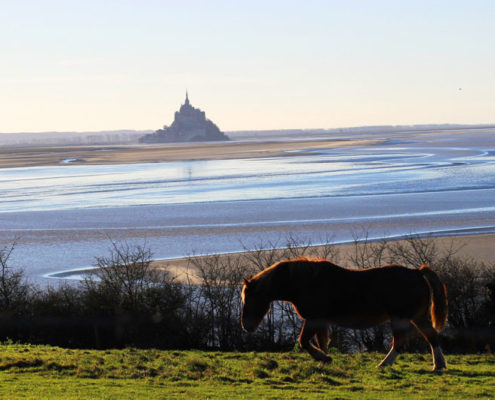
[0,131,495,279]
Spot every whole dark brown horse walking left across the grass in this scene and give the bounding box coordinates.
[241,258,448,370]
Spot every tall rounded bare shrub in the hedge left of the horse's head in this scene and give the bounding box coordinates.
[81,241,186,347]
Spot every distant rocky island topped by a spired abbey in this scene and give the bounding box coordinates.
[139,91,229,143]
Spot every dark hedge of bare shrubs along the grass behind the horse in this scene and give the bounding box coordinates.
[0,236,495,352]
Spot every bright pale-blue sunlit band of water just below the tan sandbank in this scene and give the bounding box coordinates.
[0,148,495,212]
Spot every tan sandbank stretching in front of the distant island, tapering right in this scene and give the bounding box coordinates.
[0,139,383,168]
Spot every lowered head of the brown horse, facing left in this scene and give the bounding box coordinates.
[241,279,270,332]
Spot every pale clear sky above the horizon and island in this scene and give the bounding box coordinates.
[0,0,495,133]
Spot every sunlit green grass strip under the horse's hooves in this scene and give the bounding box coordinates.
[0,344,495,400]
